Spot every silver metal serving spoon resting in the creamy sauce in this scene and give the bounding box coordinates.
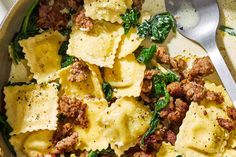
[165,0,236,107]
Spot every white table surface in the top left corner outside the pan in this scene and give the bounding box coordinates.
[0,0,16,24]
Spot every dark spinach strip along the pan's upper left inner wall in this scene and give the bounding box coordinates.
[10,0,39,63]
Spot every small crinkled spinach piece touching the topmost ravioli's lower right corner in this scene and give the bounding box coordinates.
[121,9,140,34]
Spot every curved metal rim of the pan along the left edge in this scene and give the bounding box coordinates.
[0,0,33,157]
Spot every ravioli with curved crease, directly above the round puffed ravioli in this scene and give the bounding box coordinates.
[104,54,146,97]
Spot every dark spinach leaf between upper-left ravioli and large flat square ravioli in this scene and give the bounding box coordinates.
[59,41,75,68]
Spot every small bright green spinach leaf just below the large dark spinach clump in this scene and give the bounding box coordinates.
[137,45,157,65]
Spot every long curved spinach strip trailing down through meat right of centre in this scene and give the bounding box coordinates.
[141,72,179,145]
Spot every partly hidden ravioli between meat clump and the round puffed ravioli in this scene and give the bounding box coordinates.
[74,99,108,151]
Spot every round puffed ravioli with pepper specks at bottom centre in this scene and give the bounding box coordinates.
[99,97,151,156]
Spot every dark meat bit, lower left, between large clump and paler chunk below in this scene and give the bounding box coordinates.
[52,123,73,144]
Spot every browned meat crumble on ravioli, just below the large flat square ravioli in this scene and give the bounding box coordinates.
[68,60,89,82]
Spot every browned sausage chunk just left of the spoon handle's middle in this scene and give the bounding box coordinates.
[189,57,214,77]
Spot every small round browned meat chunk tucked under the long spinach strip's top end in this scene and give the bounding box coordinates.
[167,82,184,97]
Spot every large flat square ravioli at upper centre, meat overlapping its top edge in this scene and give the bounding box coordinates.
[67,21,124,68]
